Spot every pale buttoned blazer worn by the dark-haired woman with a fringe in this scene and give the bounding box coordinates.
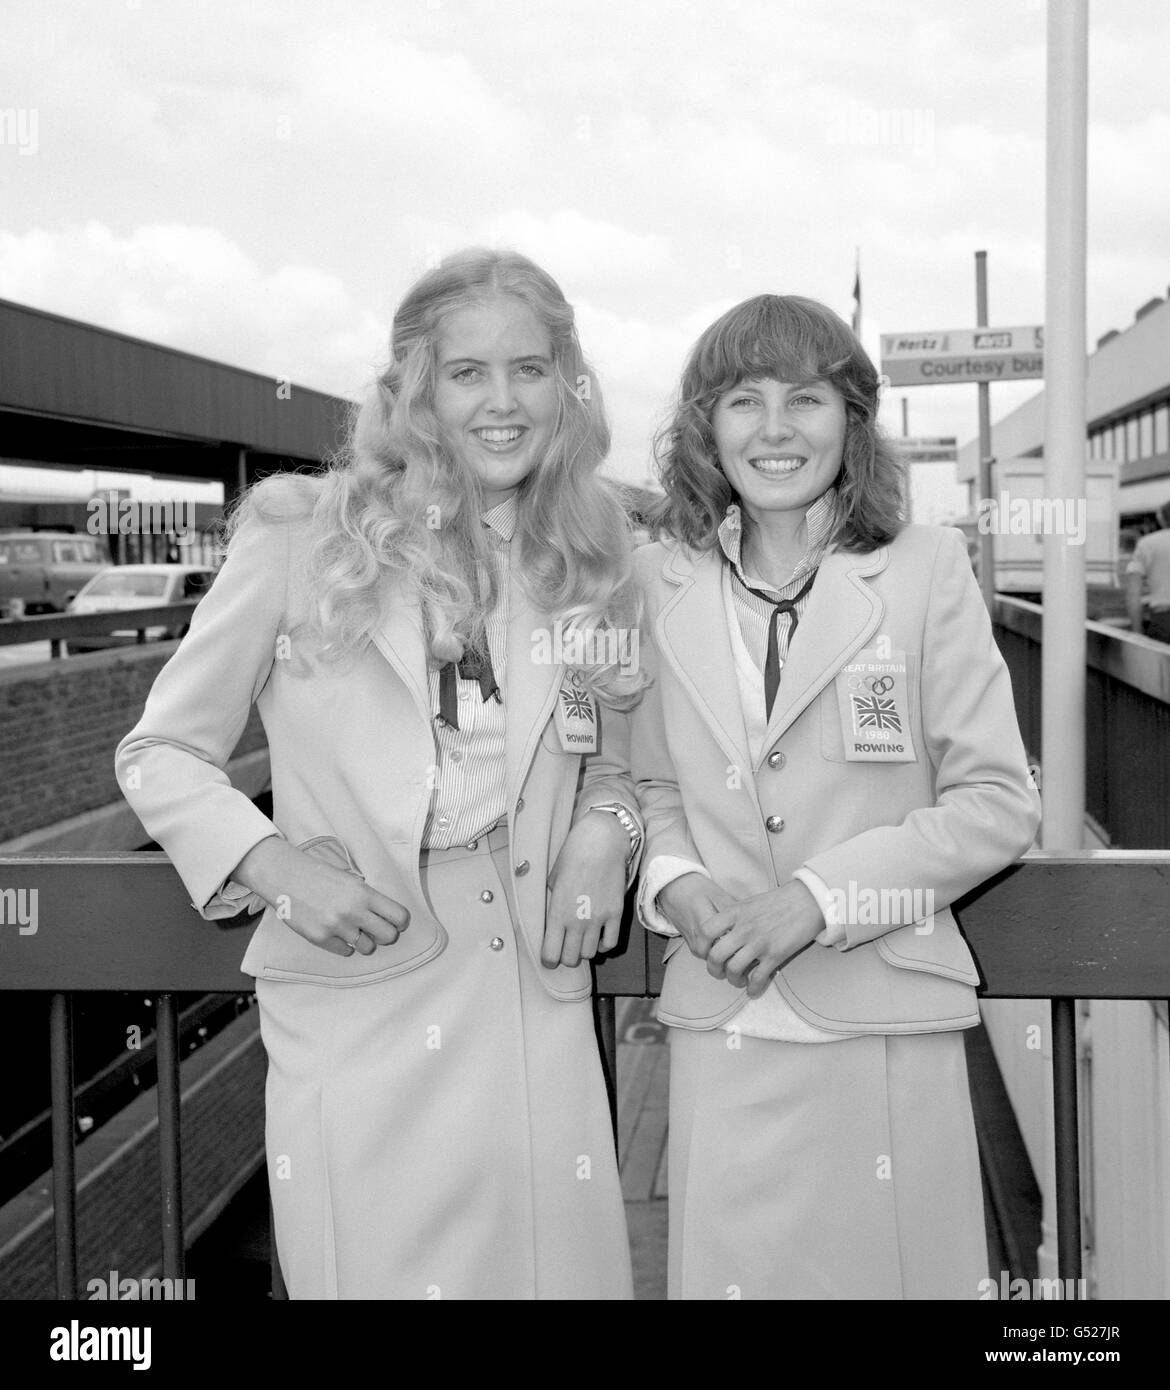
[632,525,1039,1034]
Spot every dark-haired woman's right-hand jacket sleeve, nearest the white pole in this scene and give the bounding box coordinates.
[807,527,1039,949]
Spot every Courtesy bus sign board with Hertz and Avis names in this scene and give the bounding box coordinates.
[881,324,1044,386]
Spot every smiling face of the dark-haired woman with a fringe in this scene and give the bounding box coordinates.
[711,378,846,524]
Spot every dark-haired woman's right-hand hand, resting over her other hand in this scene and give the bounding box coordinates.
[695,878,825,999]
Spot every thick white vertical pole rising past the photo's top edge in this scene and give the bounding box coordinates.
[1039,0,1088,1276]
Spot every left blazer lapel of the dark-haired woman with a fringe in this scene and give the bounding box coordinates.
[654,550,750,767]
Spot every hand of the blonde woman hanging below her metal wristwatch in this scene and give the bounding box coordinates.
[541,810,629,970]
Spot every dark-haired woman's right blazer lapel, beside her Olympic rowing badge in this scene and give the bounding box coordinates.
[764,546,889,751]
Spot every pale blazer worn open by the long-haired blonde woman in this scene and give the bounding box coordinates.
[115,508,636,999]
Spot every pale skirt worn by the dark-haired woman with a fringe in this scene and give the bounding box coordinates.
[667,1029,988,1300]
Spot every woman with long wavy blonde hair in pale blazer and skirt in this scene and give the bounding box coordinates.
[117,250,643,1298]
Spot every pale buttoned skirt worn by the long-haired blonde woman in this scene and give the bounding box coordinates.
[256,827,634,1300]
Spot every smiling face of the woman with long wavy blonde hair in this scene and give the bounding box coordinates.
[435,296,557,505]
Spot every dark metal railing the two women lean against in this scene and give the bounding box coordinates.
[0,851,1170,1298]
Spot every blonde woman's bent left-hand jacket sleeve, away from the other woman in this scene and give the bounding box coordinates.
[114,521,290,920]
